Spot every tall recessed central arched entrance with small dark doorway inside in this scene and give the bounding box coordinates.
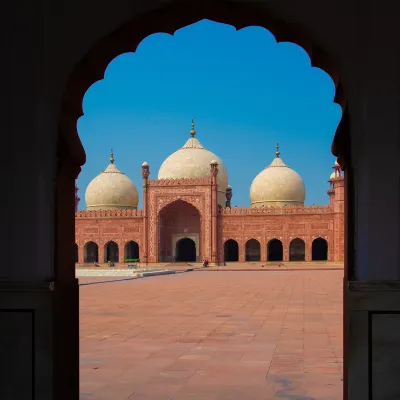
[158,200,202,262]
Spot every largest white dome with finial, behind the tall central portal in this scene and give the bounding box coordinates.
[158,122,228,206]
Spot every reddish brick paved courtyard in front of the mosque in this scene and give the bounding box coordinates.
[80,271,343,400]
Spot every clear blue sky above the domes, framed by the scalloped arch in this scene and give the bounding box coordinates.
[77,20,341,209]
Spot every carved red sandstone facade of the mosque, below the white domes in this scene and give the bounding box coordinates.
[75,170,344,264]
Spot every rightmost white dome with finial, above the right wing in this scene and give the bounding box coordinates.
[250,146,306,207]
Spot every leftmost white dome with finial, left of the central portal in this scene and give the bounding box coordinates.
[85,153,139,210]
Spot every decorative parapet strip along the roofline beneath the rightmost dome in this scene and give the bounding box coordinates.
[219,205,333,215]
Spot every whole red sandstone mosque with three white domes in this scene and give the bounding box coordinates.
[75,121,344,265]
